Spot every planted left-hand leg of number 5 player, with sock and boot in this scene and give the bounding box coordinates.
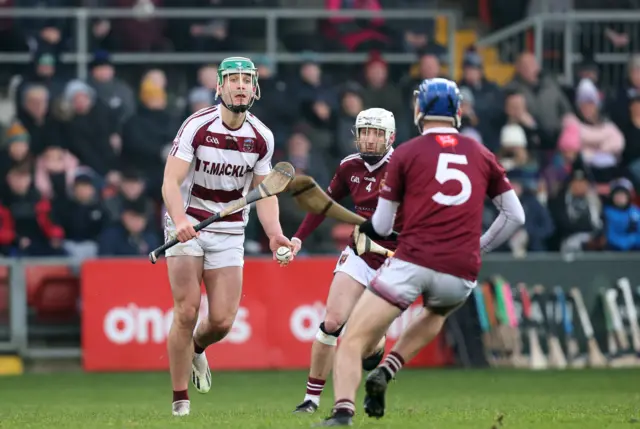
[319,290,402,426]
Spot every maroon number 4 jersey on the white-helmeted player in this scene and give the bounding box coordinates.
[294,149,402,270]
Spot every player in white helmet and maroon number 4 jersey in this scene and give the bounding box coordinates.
[291,108,402,413]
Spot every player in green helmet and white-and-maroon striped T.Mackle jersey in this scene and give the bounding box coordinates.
[162,57,293,416]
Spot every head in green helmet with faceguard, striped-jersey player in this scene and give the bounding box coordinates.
[216,57,260,113]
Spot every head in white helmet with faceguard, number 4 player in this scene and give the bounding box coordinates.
[353,107,396,165]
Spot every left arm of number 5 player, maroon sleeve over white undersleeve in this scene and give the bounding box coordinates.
[360,152,404,240]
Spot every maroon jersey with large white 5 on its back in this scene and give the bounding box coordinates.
[380,128,511,281]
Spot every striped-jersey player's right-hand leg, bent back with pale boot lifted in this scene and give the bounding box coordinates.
[191,266,242,393]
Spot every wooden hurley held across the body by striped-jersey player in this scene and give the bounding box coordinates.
[149,162,295,264]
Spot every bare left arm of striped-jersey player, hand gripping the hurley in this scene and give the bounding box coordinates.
[162,155,198,243]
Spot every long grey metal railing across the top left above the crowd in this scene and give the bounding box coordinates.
[0,8,458,79]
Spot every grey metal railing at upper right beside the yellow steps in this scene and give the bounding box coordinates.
[478,10,640,85]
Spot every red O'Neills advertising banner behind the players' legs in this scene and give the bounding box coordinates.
[82,257,452,371]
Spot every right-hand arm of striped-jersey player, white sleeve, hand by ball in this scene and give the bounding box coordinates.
[251,130,292,259]
